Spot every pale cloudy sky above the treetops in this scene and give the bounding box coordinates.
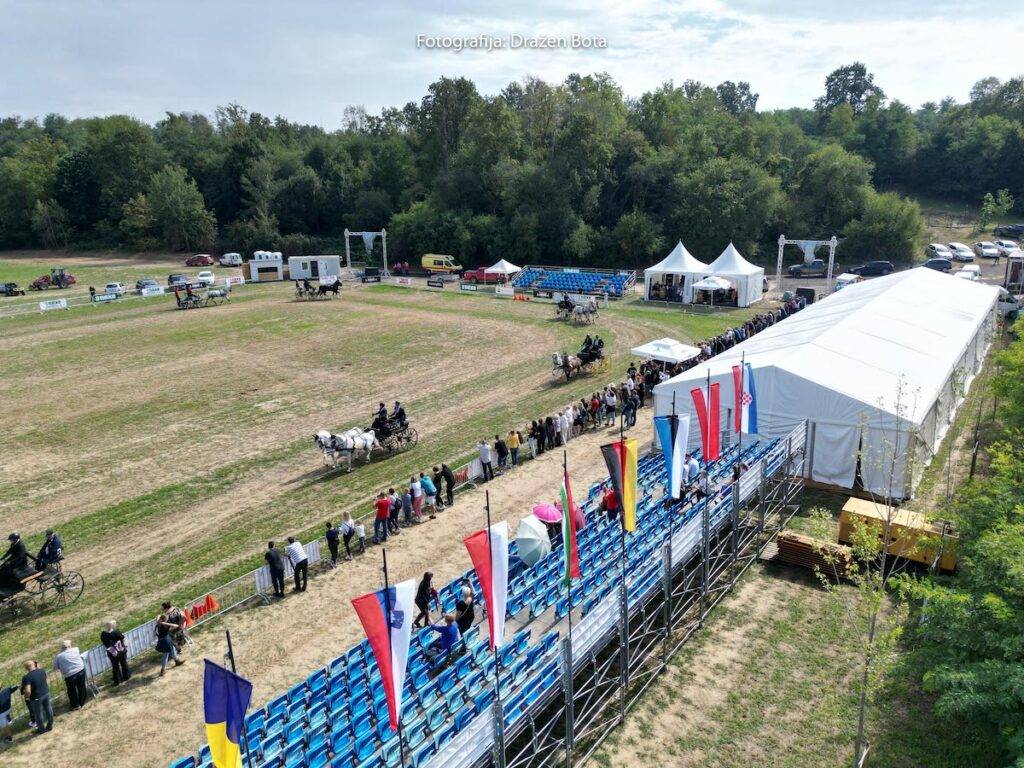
[0,0,1024,128]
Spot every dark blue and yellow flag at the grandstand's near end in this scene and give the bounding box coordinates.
[203,658,253,768]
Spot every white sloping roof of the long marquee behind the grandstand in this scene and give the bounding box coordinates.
[655,268,998,424]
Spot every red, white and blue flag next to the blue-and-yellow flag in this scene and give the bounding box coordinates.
[352,579,416,731]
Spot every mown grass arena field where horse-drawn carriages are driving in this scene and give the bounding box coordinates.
[0,257,761,765]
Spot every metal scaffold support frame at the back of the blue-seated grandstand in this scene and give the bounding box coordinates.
[440,422,807,768]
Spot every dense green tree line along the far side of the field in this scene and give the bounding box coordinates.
[0,63,1024,267]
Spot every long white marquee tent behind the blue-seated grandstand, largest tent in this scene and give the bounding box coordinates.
[654,268,998,498]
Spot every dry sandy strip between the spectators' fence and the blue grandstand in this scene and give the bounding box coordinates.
[0,411,651,768]
